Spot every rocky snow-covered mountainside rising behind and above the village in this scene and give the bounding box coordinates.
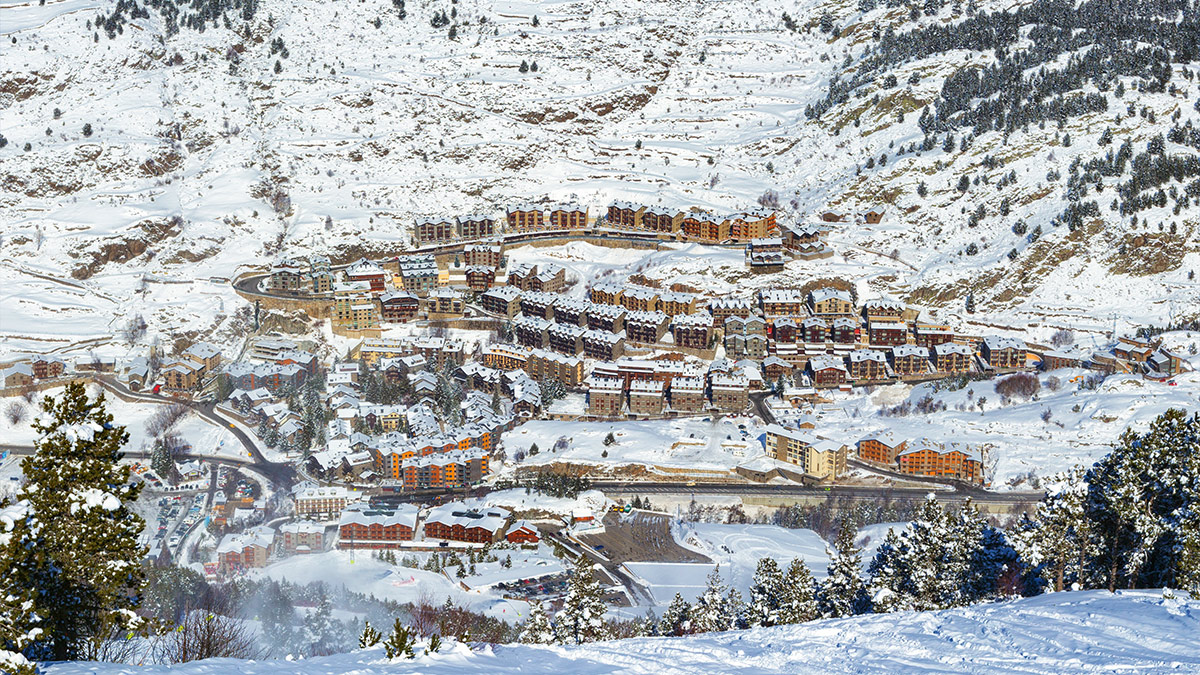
[0,0,1200,353]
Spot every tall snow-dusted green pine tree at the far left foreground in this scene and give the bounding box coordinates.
[12,382,145,661]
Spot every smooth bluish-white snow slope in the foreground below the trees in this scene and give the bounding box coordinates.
[48,591,1200,675]
